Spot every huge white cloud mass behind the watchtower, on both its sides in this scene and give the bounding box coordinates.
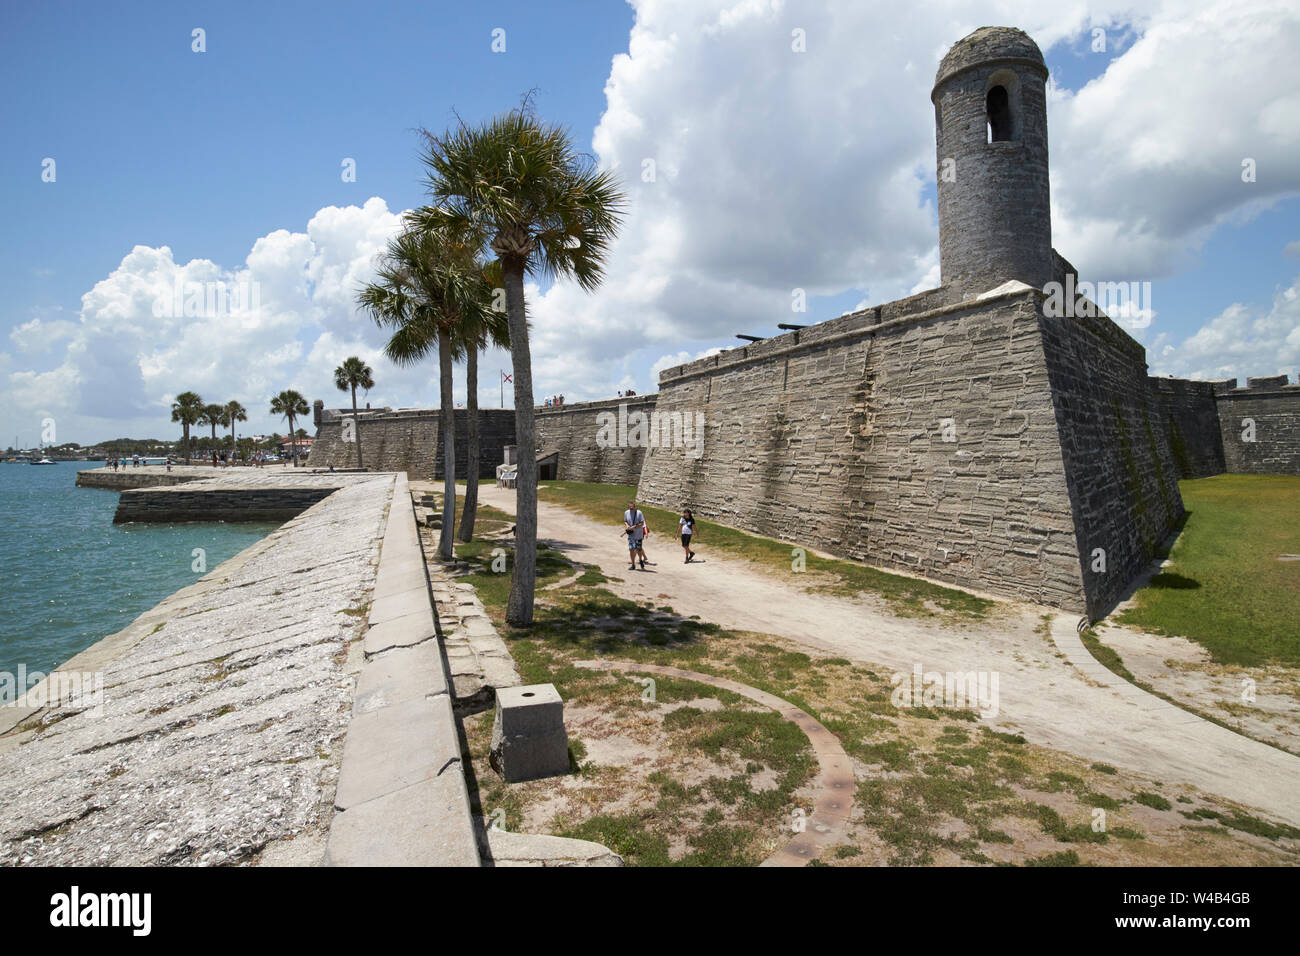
[530,0,1300,397]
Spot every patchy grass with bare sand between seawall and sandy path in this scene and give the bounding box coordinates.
[458,486,1290,866]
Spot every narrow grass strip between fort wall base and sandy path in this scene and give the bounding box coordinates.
[540,481,995,619]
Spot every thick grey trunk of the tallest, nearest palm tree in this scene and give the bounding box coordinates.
[504,263,537,627]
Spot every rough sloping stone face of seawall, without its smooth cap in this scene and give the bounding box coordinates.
[0,473,395,865]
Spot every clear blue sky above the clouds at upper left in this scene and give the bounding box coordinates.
[0,1,632,328]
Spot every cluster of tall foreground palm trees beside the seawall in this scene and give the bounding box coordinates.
[353,100,624,626]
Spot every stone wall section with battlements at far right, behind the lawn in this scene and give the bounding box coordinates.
[1214,375,1300,475]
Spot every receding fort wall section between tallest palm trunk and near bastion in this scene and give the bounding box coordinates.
[536,395,658,485]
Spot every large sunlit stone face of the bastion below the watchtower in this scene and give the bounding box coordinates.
[640,287,1107,610]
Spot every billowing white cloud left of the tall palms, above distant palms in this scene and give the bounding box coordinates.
[0,198,408,441]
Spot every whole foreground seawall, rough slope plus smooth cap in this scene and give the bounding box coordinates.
[0,473,480,866]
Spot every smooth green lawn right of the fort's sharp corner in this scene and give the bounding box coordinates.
[1119,475,1300,666]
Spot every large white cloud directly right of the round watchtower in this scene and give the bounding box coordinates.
[1048,0,1300,281]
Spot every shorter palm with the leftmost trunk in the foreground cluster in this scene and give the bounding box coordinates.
[358,228,490,561]
